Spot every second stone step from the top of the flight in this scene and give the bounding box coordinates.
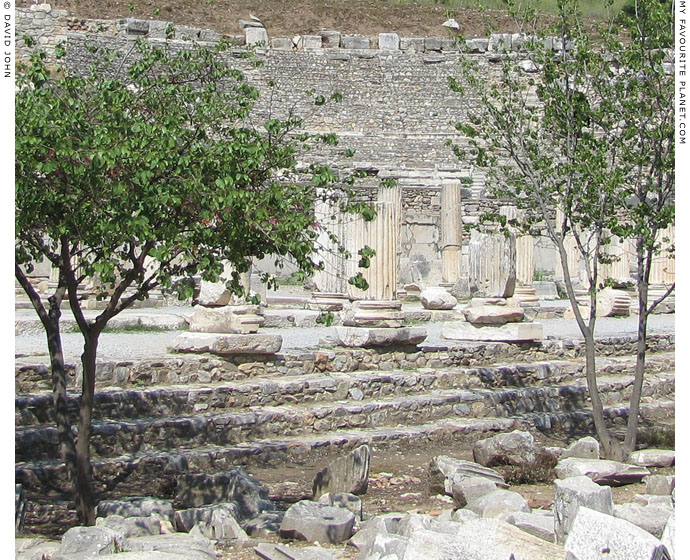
[15,353,674,426]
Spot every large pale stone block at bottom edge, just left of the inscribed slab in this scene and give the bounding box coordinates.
[403,519,564,560]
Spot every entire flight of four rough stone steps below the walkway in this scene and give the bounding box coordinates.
[15,335,675,504]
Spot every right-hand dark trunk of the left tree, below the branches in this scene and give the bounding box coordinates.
[77,333,100,525]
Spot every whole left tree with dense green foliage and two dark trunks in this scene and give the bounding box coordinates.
[15,37,372,524]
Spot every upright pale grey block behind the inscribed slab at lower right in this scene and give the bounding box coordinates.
[553,476,613,543]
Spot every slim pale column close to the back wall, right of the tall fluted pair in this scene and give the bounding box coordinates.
[441,181,462,286]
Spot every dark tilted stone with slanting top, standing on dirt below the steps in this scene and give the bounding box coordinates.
[312,445,371,500]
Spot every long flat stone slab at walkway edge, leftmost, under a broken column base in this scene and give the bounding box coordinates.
[173,332,283,356]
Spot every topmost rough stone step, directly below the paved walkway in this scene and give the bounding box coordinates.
[15,334,675,393]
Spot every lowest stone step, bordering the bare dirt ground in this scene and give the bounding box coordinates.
[15,399,675,498]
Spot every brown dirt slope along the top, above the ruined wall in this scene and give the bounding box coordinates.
[18,0,552,38]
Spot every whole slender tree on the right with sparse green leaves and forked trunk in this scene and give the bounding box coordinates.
[451,0,675,459]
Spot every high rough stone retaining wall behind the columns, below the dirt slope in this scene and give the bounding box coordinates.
[17,8,576,286]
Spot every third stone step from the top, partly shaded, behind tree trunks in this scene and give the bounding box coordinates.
[15,373,675,461]
